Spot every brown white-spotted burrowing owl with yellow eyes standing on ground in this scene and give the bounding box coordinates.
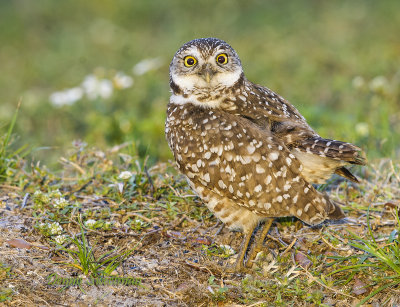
[165,38,365,270]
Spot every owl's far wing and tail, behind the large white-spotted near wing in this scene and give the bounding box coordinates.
[231,81,366,183]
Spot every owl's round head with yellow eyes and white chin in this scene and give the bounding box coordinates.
[169,38,243,93]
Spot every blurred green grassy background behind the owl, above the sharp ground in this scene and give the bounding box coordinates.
[0,0,400,168]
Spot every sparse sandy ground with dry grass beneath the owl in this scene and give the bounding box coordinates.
[0,144,400,306]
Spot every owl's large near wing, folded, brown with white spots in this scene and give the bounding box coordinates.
[167,105,343,224]
